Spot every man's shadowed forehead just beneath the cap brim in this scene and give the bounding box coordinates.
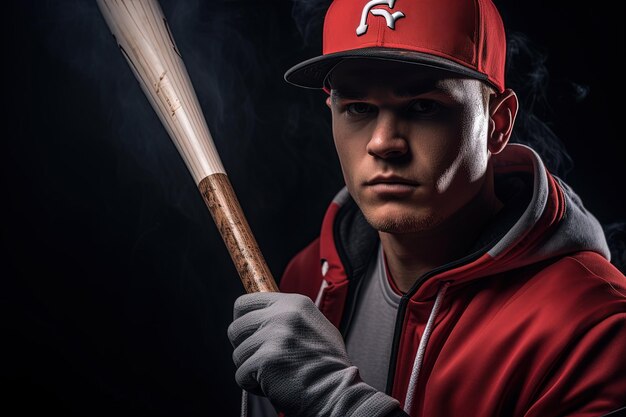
[328,58,480,97]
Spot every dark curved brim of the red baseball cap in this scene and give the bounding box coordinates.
[285,47,487,89]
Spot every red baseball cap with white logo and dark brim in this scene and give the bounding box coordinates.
[285,0,506,92]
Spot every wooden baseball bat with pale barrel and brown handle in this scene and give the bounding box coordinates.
[97,0,278,293]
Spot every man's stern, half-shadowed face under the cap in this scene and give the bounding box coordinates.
[327,60,489,233]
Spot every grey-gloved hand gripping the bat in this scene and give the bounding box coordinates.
[228,293,399,417]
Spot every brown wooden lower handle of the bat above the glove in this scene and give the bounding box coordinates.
[198,173,278,293]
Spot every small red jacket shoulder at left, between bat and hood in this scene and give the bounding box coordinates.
[280,237,323,299]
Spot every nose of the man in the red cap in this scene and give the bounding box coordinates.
[367,110,409,159]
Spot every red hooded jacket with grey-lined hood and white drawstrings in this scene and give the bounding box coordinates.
[280,145,626,417]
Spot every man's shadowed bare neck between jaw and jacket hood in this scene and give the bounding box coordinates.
[378,172,503,293]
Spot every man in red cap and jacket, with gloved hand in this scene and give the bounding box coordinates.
[228,0,626,417]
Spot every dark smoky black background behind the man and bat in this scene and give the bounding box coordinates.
[6,0,626,416]
